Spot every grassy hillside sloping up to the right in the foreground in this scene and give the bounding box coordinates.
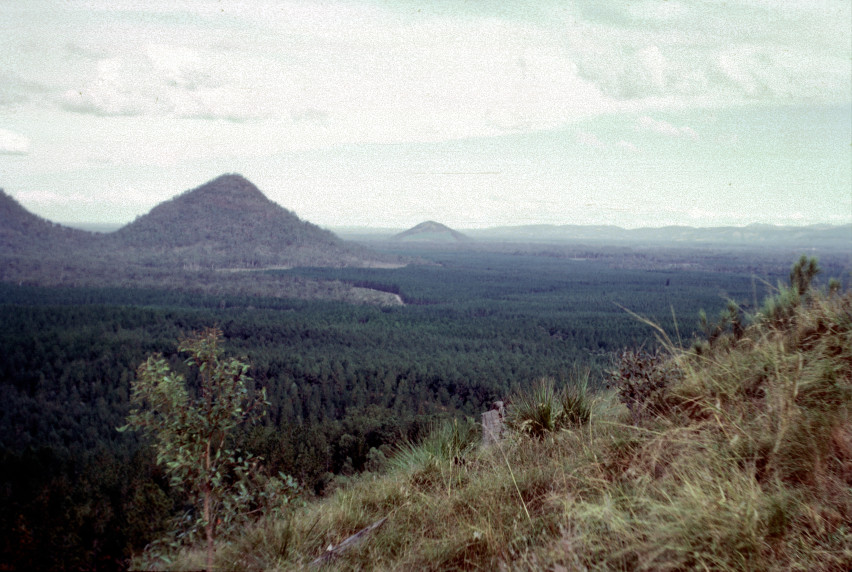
[161,282,852,571]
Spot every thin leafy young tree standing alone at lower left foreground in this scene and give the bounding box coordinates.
[119,328,295,569]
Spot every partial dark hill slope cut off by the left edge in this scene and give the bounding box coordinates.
[0,189,95,255]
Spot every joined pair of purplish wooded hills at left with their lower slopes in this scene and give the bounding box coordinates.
[0,175,405,305]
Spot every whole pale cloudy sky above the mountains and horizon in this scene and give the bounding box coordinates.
[0,0,852,229]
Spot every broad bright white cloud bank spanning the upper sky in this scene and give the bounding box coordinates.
[6,0,852,156]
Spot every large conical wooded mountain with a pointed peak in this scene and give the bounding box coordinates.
[105,174,398,269]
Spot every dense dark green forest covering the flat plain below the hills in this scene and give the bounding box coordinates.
[0,250,832,569]
